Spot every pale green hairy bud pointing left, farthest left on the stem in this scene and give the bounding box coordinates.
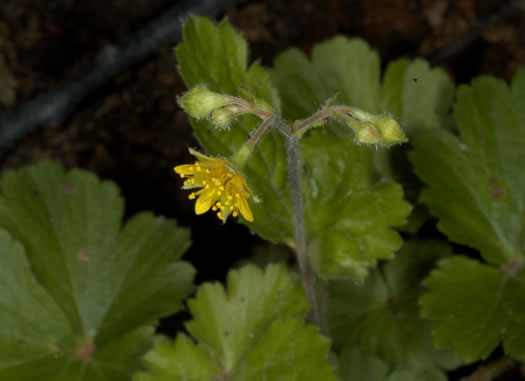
[177,85,232,119]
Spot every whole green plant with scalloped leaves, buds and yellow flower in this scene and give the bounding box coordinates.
[0,17,525,381]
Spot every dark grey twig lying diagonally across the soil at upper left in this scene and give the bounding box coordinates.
[0,0,234,154]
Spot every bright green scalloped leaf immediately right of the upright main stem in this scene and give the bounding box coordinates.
[302,132,411,281]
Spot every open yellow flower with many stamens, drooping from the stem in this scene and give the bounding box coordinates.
[174,148,253,222]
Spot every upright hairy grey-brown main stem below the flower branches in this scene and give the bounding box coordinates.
[287,136,321,327]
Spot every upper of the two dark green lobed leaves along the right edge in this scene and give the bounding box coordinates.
[411,70,525,264]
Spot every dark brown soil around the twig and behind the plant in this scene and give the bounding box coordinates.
[0,0,525,379]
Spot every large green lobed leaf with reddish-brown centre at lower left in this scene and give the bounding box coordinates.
[0,161,194,380]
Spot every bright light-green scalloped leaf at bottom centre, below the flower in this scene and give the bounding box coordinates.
[135,265,336,381]
